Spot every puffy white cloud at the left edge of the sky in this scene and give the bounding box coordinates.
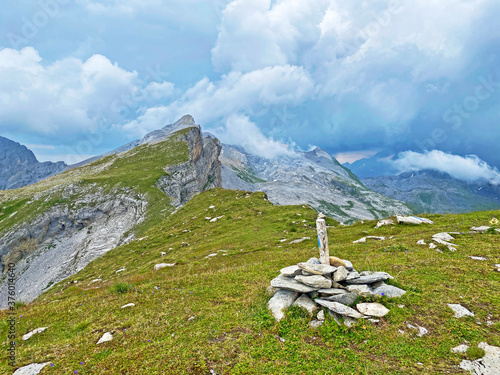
[0,47,174,137]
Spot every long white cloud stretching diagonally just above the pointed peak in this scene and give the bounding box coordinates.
[124,65,314,136]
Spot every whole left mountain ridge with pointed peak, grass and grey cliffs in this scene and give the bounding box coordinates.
[0,118,221,307]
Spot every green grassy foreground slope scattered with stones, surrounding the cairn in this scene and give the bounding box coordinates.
[0,189,500,374]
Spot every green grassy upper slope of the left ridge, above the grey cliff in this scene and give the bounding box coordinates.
[0,128,190,244]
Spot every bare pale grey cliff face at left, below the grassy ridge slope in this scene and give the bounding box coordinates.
[0,185,148,307]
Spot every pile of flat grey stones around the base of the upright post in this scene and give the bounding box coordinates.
[267,257,406,327]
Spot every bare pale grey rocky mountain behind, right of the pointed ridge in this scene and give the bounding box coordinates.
[220,145,411,222]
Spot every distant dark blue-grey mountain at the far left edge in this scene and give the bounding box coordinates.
[0,137,67,190]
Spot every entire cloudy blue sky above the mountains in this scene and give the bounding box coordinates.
[0,0,500,181]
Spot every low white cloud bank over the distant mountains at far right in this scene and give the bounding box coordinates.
[390,150,500,185]
